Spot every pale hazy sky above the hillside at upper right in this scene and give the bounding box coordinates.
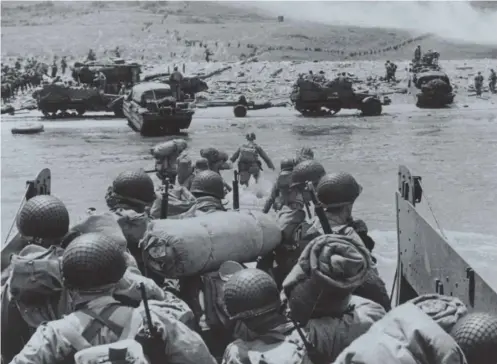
[231,1,497,45]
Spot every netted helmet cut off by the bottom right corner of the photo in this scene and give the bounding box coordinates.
[450,312,497,364]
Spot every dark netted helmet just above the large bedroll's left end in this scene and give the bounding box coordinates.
[112,169,156,204]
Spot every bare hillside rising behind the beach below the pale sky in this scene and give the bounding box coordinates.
[1,1,497,63]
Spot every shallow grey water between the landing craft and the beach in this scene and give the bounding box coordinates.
[1,105,497,288]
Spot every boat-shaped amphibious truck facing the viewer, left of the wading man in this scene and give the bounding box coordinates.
[123,82,195,136]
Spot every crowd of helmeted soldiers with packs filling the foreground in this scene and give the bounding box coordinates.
[1,134,497,364]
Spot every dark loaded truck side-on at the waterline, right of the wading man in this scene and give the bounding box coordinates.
[290,77,382,116]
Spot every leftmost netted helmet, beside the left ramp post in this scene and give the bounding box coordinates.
[16,195,69,239]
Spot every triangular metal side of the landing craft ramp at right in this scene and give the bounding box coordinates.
[394,166,497,314]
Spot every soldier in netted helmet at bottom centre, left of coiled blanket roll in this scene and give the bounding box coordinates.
[221,269,306,364]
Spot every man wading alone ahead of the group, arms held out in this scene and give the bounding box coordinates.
[231,133,274,186]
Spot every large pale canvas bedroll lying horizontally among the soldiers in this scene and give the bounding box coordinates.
[140,211,282,278]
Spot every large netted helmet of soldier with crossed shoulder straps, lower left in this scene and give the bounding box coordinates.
[62,233,126,290]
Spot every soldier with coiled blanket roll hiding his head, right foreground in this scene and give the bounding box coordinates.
[283,234,386,363]
